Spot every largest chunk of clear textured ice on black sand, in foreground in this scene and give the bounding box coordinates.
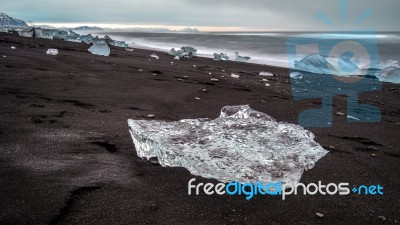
[128,105,328,183]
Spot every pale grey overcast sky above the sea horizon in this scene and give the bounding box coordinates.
[0,0,400,31]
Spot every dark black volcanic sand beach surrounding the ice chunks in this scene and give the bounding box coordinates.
[0,34,400,224]
